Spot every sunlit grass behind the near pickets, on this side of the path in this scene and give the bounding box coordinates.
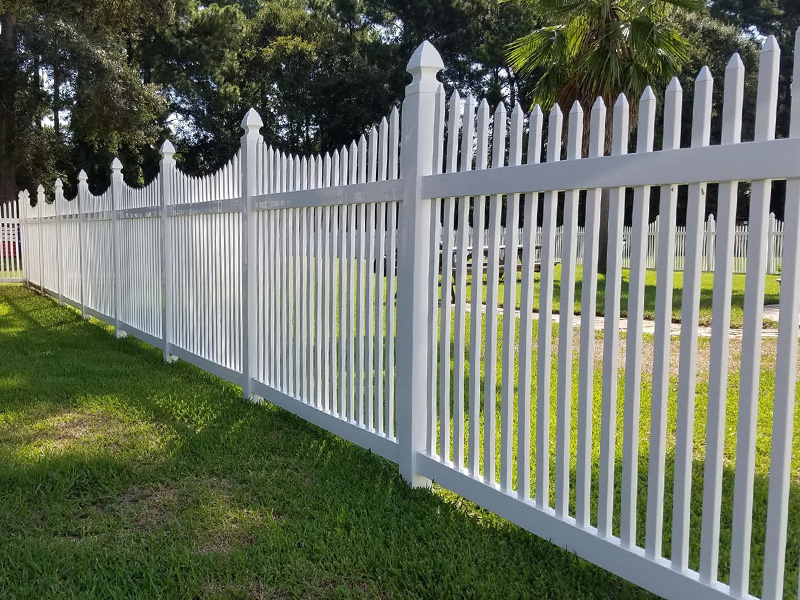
[437,310,800,599]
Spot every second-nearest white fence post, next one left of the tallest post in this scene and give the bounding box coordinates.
[241,108,264,400]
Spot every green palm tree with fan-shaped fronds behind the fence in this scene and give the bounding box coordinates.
[507,0,704,273]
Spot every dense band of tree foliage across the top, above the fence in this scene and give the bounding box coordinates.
[0,0,800,201]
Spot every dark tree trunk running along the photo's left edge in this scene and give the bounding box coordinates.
[0,10,18,202]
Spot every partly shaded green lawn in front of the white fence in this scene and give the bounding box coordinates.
[0,286,651,600]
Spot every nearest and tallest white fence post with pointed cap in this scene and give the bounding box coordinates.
[397,41,444,487]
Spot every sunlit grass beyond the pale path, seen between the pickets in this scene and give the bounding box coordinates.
[467,264,781,327]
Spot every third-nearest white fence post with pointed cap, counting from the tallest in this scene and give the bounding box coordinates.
[159,140,176,362]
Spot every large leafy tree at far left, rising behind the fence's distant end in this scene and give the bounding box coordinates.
[0,0,173,202]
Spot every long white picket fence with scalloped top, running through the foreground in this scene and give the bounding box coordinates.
[15,38,800,600]
